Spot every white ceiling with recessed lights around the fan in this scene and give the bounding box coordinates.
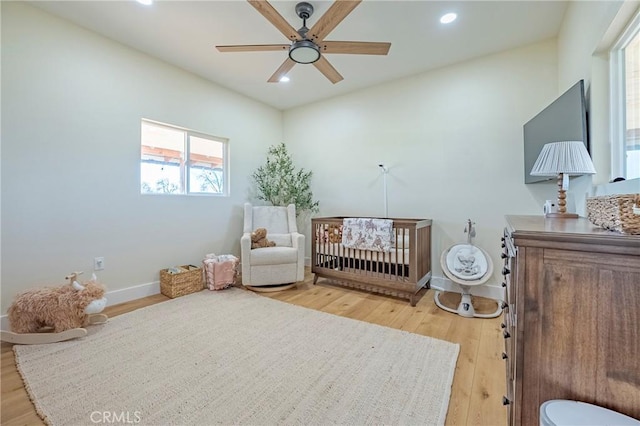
[31,0,567,110]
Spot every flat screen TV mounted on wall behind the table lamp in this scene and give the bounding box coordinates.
[524,80,589,183]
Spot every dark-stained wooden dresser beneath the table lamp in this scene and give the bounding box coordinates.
[502,216,640,426]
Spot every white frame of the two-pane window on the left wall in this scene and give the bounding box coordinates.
[138,118,230,197]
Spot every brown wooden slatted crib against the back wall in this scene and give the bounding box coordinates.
[311,217,431,306]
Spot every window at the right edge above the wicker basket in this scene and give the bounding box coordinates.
[611,10,640,179]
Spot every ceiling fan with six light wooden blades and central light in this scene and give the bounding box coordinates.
[216,0,391,84]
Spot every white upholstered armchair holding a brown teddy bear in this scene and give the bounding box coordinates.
[240,203,305,291]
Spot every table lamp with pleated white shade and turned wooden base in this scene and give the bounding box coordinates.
[531,141,596,219]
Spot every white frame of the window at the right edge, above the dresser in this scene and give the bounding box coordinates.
[609,11,640,179]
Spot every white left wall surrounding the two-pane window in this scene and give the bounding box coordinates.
[1,2,282,312]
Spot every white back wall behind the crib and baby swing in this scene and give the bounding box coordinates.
[284,41,557,283]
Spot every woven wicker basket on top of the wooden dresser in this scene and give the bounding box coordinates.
[587,194,640,235]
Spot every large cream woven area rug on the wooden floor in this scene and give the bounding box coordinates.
[14,288,459,426]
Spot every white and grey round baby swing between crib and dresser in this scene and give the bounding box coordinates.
[434,220,502,318]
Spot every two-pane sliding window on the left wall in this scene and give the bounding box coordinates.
[140,120,229,195]
